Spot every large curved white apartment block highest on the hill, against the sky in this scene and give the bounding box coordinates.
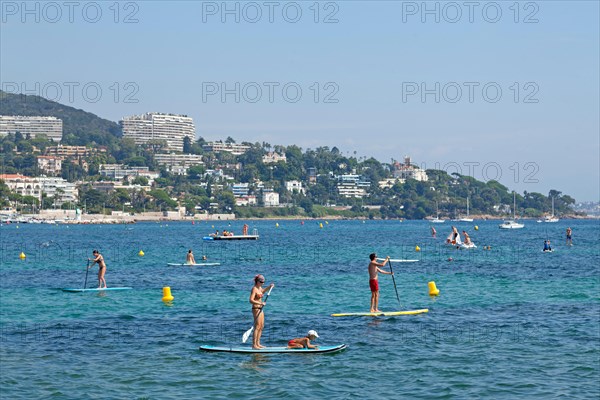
[120,112,196,151]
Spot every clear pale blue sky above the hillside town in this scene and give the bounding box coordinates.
[0,0,600,201]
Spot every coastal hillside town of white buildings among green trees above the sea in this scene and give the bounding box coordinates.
[0,94,598,219]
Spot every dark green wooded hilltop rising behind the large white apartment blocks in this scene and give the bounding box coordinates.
[0,90,121,146]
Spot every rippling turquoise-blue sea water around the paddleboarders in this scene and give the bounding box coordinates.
[0,221,600,399]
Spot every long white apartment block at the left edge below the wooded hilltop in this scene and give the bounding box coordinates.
[0,115,63,142]
